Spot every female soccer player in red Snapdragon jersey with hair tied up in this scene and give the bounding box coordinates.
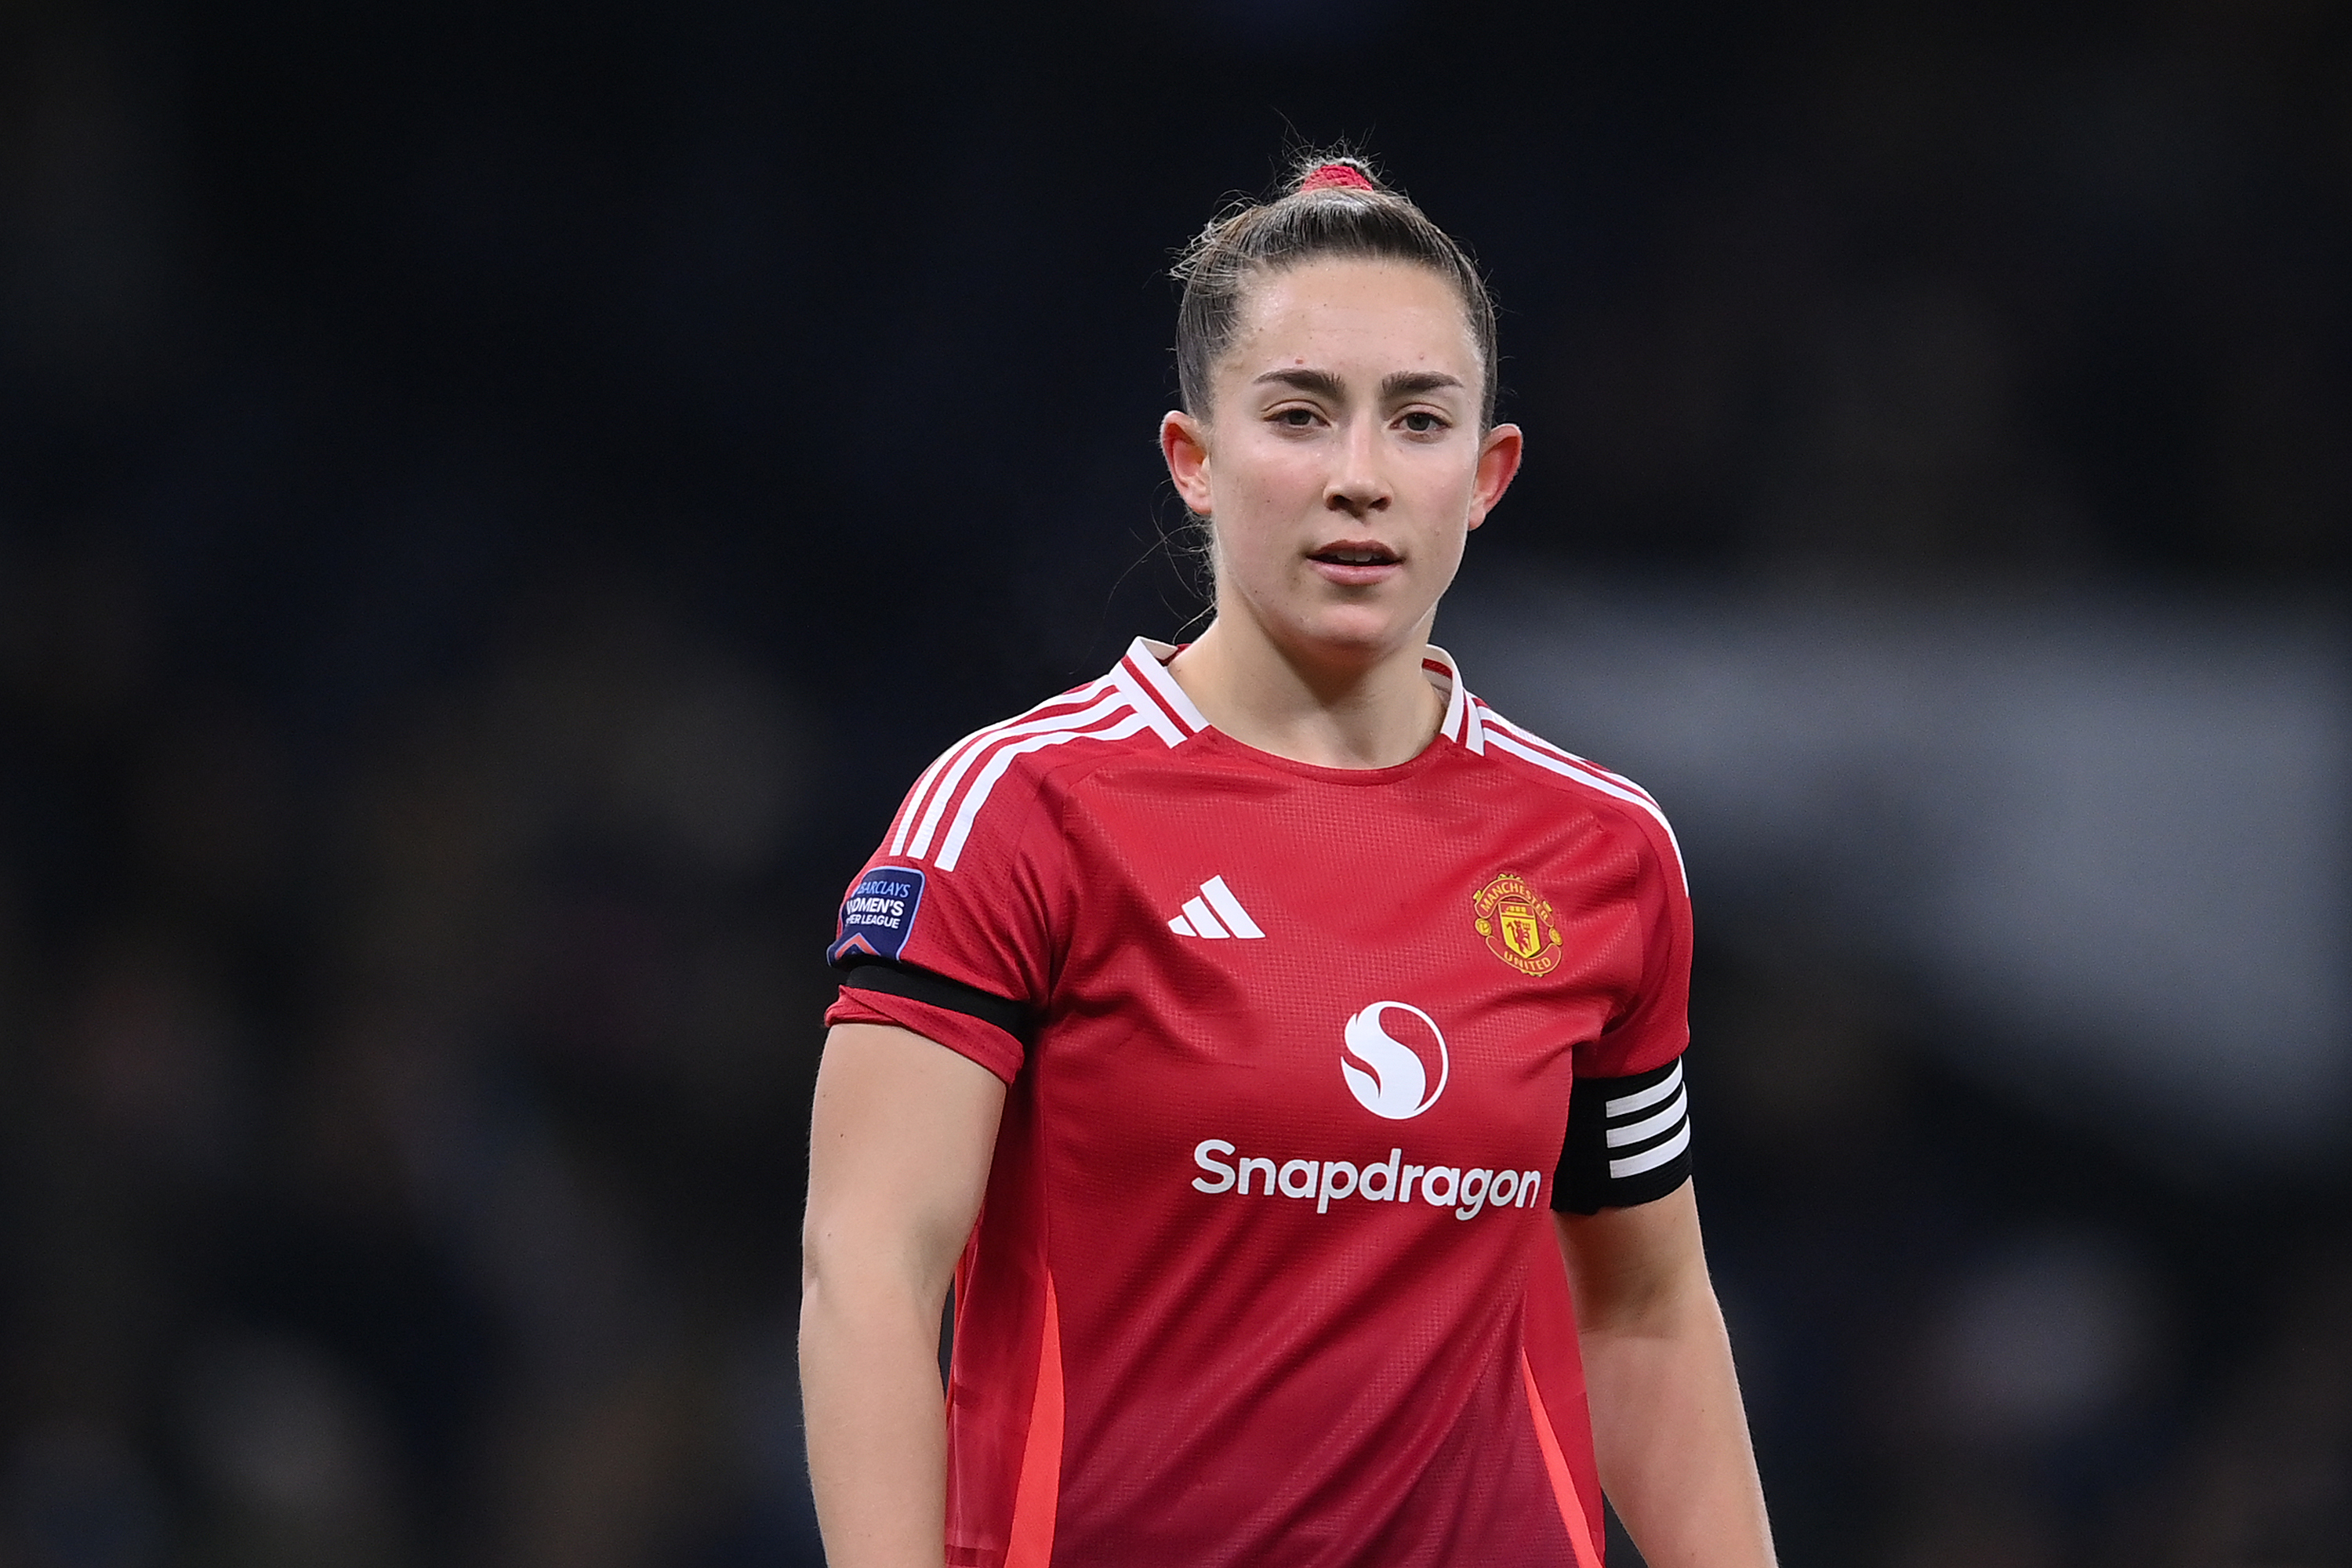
[800,160,1771,1568]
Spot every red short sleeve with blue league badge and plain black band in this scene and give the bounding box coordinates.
[826,747,1065,1081]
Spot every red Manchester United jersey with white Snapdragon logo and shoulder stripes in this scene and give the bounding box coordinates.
[826,640,1691,1568]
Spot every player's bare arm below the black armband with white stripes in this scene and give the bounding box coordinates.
[1552,1182,1773,1568]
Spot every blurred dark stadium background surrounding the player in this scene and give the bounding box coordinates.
[0,0,2352,1568]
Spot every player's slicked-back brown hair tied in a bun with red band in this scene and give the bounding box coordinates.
[1176,153,1496,428]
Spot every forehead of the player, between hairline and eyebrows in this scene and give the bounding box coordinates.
[1223,259,1479,386]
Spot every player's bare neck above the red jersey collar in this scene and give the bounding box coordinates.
[1169,614,1446,769]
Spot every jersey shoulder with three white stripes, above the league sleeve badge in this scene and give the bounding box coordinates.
[887,663,1188,872]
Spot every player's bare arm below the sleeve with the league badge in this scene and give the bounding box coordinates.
[800,1022,1004,1568]
